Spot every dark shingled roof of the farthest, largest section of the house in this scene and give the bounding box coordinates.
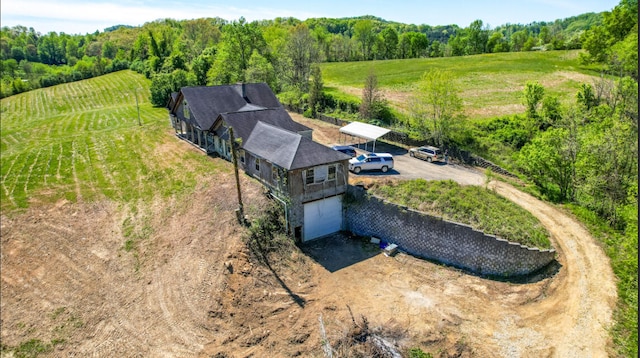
[180,83,283,130]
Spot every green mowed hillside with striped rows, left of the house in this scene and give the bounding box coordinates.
[0,70,228,213]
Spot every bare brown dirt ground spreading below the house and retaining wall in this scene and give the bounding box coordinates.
[0,115,616,357]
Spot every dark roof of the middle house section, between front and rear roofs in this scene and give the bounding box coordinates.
[217,107,311,144]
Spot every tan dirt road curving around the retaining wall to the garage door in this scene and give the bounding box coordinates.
[310,182,616,358]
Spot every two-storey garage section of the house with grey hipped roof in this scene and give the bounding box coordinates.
[238,122,351,241]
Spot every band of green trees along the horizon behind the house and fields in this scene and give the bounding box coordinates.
[0,5,620,98]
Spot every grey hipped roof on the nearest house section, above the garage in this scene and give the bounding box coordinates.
[242,122,350,170]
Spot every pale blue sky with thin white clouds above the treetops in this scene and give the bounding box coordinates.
[0,0,620,35]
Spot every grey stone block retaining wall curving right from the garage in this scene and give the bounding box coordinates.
[345,186,556,277]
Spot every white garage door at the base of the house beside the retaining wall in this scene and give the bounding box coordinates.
[303,195,342,241]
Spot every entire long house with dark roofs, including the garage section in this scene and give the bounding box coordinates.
[168,83,350,241]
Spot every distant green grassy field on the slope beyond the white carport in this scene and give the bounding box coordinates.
[321,50,597,118]
